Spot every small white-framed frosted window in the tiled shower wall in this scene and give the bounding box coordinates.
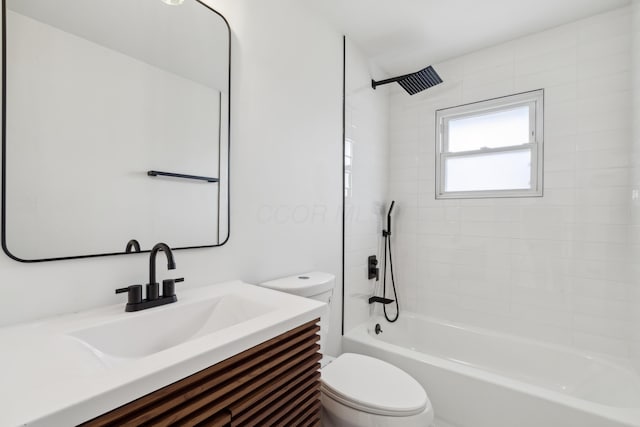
[436,89,544,199]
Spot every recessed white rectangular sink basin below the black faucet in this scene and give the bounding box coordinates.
[69,294,274,358]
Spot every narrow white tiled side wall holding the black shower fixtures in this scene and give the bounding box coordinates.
[345,39,389,331]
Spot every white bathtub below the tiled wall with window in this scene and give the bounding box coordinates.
[343,313,640,427]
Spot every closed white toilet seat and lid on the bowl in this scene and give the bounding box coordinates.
[322,353,428,417]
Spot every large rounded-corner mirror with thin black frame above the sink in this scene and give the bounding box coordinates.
[2,0,231,262]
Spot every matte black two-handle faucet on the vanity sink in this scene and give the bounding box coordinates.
[116,243,184,311]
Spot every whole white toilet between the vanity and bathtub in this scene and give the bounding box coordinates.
[260,272,433,427]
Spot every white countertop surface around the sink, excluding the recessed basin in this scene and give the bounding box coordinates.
[0,281,326,427]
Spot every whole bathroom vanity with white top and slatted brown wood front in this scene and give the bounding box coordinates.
[0,281,325,426]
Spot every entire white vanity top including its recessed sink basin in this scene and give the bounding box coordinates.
[0,280,326,427]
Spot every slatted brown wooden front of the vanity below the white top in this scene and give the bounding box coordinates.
[82,319,321,427]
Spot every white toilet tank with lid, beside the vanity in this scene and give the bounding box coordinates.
[260,271,336,355]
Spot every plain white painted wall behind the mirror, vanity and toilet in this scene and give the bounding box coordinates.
[0,0,342,353]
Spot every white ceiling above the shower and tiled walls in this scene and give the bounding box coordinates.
[303,0,631,77]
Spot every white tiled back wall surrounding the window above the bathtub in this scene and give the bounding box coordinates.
[389,8,634,357]
